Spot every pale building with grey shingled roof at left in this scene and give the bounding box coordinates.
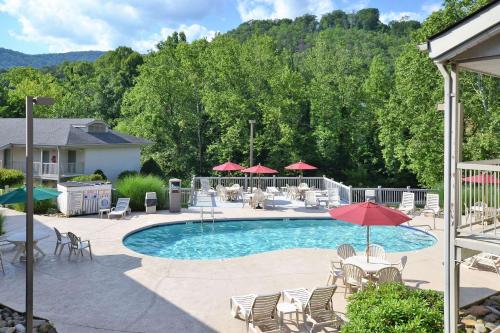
[0,118,149,181]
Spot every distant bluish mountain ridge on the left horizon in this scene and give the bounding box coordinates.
[0,47,106,70]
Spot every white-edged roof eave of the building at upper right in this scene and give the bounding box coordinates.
[421,0,500,77]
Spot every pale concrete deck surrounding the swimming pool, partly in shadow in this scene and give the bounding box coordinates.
[0,208,500,333]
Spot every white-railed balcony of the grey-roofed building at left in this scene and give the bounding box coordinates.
[4,161,84,179]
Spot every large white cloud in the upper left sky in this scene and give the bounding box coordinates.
[0,0,224,52]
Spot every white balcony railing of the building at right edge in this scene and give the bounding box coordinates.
[457,159,500,238]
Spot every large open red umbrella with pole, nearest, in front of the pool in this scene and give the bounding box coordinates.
[329,201,411,261]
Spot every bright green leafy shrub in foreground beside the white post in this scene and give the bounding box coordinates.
[342,284,444,333]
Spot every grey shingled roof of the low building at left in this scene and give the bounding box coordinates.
[0,118,150,147]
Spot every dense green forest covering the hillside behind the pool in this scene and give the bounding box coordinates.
[0,0,500,187]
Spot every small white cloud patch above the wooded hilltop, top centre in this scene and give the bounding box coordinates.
[237,0,334,21]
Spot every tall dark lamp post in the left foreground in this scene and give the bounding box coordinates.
[26,96,54,332]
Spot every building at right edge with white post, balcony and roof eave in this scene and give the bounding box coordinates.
[420,0,500,333]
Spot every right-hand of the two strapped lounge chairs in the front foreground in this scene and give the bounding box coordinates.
[303,285,342,333]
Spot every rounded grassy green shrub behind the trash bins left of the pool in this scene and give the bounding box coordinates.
[116,175,165,211]
